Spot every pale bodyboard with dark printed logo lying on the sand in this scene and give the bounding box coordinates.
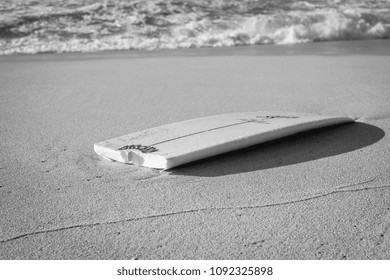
[94,111,354,169]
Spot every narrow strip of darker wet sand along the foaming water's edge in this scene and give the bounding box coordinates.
[0,39,390,61]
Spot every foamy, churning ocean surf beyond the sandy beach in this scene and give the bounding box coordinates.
[0,0,390,55]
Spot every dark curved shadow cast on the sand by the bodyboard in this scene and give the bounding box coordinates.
[170,122,385,177]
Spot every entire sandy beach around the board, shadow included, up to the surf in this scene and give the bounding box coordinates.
[0,40,390,259]
